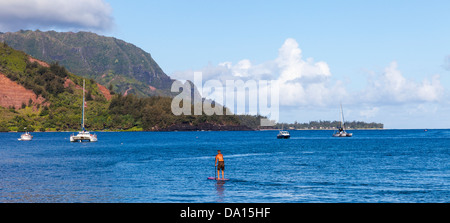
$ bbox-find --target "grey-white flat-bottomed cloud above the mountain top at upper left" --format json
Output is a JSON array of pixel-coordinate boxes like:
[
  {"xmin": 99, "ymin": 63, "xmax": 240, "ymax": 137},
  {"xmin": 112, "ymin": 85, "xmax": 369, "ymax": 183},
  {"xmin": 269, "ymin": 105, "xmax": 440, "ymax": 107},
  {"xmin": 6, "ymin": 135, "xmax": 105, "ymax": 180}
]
[{"xmin": 0, "ymin": 0, "xmax": 114, "ymax": 31}]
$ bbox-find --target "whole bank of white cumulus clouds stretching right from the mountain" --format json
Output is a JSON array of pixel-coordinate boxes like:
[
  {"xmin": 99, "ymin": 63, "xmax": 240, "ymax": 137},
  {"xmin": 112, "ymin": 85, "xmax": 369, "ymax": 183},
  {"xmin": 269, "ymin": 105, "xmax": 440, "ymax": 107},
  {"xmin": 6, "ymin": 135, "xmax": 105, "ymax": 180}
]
[{"xmin": 171, "ymin": 38, "xmax": 444, "ymax": 118}]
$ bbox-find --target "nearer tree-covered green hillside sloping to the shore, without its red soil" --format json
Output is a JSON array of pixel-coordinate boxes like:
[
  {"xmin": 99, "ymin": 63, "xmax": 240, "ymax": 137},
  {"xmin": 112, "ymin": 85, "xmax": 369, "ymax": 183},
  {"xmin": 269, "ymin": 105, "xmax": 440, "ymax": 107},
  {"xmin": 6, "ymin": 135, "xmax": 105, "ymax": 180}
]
[{"xmin": 0, "ymin": 43, "xmax": 251, "ymax": 132}]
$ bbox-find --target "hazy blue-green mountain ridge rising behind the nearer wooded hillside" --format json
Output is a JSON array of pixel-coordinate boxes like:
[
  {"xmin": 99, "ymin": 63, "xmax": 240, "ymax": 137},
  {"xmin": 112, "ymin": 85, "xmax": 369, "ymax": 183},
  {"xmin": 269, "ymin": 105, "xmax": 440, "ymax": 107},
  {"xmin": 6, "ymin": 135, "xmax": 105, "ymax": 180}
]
[{"xmin": 0, "ymin": 30, "xmax": 174, "ymax": 97}]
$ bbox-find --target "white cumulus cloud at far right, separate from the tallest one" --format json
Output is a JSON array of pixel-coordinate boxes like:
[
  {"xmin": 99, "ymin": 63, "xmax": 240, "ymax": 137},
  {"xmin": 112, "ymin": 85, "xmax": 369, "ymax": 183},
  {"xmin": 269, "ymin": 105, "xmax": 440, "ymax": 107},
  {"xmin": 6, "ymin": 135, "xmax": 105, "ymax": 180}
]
[{"xmin": 360, "ymin": 61, "xmax": 444, "ymax": 104}]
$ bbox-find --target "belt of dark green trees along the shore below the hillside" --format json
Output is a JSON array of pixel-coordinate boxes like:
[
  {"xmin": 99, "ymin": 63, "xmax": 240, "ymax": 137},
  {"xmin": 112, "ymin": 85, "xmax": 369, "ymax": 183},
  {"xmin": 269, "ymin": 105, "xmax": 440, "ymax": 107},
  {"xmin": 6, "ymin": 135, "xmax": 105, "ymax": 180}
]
[{"xmin": 0, "ymin": 92, "xmax": 246, "ymax": 131}]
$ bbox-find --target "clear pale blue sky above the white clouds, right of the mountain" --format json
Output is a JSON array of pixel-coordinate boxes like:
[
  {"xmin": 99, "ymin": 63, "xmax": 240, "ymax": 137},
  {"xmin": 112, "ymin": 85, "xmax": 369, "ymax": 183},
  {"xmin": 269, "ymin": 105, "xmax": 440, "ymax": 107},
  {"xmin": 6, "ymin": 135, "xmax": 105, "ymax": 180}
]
[{"xmin": 108, "ymin": 1, "xmax": 450, "ymax": 75}]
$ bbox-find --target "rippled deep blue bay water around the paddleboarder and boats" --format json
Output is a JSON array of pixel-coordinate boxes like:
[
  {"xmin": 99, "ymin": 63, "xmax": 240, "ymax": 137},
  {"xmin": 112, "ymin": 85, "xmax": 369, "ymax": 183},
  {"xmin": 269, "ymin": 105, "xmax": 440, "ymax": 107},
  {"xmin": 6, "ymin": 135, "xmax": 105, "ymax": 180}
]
[{"xmin": 0, "ymin": 130, "xmax": 450, "ymax": 203}]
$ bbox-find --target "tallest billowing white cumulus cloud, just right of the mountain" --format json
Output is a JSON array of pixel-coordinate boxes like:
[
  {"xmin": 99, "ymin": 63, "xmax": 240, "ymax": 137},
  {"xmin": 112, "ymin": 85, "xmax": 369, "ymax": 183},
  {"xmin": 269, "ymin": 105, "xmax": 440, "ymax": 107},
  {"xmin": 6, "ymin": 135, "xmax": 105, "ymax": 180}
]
[{"xmin": 171, "ymin": 38, "xmax": 347, "ymax": 106}]
